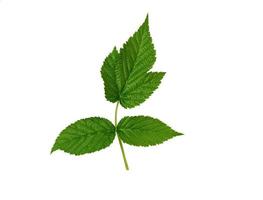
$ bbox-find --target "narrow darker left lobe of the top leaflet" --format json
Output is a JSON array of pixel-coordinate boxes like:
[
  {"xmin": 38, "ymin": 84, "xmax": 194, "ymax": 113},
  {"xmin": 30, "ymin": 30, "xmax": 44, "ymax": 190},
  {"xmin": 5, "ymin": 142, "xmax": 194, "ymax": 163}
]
[{"xmin": 101, "ymin": 47, "xmax": 119, "ymax": 103}]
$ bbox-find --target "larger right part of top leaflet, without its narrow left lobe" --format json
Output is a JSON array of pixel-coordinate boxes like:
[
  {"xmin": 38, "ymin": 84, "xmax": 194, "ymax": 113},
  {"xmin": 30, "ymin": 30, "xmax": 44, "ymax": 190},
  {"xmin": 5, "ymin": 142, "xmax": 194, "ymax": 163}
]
[{"xmin": 115, "ymin": 15, "xmax": 164, "ymax": 108}]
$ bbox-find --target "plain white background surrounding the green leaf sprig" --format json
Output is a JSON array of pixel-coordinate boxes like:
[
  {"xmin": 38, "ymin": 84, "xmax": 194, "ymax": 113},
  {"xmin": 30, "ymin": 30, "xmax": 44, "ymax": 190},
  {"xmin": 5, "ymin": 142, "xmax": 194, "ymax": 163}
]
[{"xmin": 0, "ymin": 0, "xmax": 263, "ymax": 200}]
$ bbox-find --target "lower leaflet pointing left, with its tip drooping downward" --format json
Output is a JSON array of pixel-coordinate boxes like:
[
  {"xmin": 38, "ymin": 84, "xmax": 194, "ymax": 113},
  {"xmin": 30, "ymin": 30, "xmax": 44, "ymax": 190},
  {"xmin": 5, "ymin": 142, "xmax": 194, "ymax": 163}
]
[{"xmin": 51, "ymin": 117, "xmax": 115, "ymax": 155}]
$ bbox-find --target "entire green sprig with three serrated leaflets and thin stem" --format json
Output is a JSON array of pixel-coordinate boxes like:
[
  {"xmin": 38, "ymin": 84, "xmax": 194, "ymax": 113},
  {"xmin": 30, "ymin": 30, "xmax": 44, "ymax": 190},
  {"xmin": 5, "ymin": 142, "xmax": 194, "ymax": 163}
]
[{"xmin": 51, "ymin": 16, "xmax": 182, "ymax": 170}]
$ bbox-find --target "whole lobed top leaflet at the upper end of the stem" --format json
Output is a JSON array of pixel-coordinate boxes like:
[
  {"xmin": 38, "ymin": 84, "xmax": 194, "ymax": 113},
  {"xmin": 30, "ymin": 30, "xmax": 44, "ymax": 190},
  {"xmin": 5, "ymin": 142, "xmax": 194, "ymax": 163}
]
[{"xmin": 101, "ymin": 16, "xmax": 165, "ymax": 108}]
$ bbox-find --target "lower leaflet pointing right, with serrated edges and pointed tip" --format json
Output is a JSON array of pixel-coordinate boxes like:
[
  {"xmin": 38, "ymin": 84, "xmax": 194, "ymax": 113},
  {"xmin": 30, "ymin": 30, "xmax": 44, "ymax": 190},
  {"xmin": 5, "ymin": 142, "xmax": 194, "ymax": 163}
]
[{"xmin": 117, "ymin": 116, "xmax": 183, "ymax": 146}]
